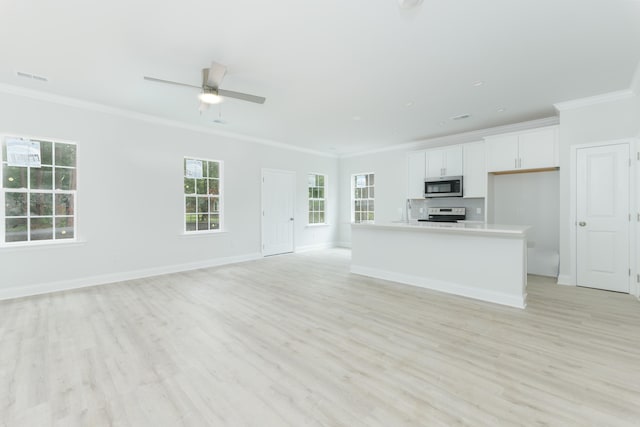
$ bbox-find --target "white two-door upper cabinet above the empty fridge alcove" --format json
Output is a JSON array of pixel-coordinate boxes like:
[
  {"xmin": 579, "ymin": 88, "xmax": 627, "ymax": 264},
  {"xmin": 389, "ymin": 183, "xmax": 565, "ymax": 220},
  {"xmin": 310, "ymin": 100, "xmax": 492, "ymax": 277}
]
[{"xmin": 485, "ymin": 126, "xmax": 559, "ymax": 172}]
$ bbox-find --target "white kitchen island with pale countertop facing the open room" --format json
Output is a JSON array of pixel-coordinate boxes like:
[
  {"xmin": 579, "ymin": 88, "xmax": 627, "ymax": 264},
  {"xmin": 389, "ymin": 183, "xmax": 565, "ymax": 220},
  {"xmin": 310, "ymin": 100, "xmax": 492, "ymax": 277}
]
[{"xmin": 351, "ymin": 222, "xmax": 529, "ymax": 308}]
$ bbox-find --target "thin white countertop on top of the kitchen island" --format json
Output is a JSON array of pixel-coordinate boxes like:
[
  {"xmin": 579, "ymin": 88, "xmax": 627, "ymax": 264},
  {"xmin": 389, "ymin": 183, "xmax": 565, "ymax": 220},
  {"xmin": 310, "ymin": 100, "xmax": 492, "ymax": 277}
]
[{"xmin": 351, "ymin": 221, "xmax": 531, "ymax": 237}]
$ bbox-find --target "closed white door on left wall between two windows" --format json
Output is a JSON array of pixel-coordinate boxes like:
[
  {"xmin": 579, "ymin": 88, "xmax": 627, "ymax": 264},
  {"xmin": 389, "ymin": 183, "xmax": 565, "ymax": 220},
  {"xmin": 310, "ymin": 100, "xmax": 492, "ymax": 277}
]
[{"xmin": 262, "ymin": 169, "xmax": 296, "ymax": 256}]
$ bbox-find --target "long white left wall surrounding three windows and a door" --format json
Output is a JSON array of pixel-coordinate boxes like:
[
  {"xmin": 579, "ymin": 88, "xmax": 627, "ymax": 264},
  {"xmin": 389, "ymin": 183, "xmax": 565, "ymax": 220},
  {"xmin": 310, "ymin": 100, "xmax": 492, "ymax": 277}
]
[{"xmin": 0, "ymin": 94, "xmax": 339, "ymax": 298}]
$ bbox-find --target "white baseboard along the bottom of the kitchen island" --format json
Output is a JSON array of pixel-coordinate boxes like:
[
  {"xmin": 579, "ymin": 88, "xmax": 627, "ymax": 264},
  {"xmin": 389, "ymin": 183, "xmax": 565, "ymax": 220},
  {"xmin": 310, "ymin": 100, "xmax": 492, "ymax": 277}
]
[{"xmin": 351, "ymin": 265, "xmax": 527, "ymax": 308}]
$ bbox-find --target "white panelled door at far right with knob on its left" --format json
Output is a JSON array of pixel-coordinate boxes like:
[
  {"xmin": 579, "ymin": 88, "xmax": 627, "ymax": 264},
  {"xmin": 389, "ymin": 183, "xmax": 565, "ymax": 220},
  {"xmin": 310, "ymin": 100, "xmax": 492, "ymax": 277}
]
[{"xmin": 576, "ymin": 144, "xmax": 630, "ymax": 293}]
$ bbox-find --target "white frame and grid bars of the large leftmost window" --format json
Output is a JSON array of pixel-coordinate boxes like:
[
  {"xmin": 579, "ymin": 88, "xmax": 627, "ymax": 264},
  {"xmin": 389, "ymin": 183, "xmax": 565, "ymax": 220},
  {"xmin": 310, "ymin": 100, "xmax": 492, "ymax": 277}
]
[{"xmin": 0, "ymin": 134, "xmax": 80, "ymax": 248}]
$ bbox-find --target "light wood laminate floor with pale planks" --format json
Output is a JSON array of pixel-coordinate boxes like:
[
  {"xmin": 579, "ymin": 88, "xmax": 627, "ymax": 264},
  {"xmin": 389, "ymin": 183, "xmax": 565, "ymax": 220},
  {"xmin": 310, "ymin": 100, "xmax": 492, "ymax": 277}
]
[{"xmin": 0, "ymin": 249, "xmax": 640, "ymax": 427}]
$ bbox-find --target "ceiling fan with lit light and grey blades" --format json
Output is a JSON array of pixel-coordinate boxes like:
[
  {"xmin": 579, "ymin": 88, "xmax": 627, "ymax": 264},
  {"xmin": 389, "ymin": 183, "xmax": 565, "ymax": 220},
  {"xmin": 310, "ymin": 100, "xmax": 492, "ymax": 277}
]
[{"xmin": 144, "ymin": 62, "xmax": 266, "ymax": 110}]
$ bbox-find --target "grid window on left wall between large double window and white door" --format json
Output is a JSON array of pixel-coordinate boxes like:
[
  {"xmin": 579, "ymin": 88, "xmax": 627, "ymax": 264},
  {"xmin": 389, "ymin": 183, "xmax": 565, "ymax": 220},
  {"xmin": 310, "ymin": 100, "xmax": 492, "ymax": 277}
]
[{"xmin": 184, "ymin": 157, "xmax": 222, "ymax": 232}]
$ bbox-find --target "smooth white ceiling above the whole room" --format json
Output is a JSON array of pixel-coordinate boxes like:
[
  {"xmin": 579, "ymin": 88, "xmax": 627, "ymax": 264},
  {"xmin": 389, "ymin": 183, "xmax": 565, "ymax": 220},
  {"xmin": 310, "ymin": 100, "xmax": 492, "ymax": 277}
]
[{"xmin": 0, "ymin": 0, "xmax": 640, "ymax": 154}]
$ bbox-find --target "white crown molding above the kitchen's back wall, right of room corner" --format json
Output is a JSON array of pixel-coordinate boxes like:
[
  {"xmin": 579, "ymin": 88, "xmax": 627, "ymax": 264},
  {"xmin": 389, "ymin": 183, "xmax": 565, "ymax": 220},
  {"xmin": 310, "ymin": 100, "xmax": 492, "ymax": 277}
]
[{"xmin": 340, "ymin": 116, "xmax": 560, "ymax": 159}]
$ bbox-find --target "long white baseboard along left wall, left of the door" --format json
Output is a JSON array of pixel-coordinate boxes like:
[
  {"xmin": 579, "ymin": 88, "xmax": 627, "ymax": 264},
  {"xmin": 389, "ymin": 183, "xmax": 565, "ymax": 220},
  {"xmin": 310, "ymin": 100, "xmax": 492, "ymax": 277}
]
[{"xmin": 0, "ymin": 253, "xmax": 262, "ymax": 301}]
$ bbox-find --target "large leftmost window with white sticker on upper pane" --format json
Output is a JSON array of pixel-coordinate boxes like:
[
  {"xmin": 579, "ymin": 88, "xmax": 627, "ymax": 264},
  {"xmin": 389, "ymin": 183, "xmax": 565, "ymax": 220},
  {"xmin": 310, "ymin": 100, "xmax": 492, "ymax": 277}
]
[{"xmin": 2, "ymin": 137, "xmax": 76, "ymax": 243}]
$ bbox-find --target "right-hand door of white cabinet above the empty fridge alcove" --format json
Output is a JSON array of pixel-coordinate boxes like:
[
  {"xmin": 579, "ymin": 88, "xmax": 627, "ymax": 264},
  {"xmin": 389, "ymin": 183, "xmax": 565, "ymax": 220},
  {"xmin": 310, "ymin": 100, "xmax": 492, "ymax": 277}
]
[{"xmin": 519, "ymin": 128, "xmax": 559, "ymax": 169}]
